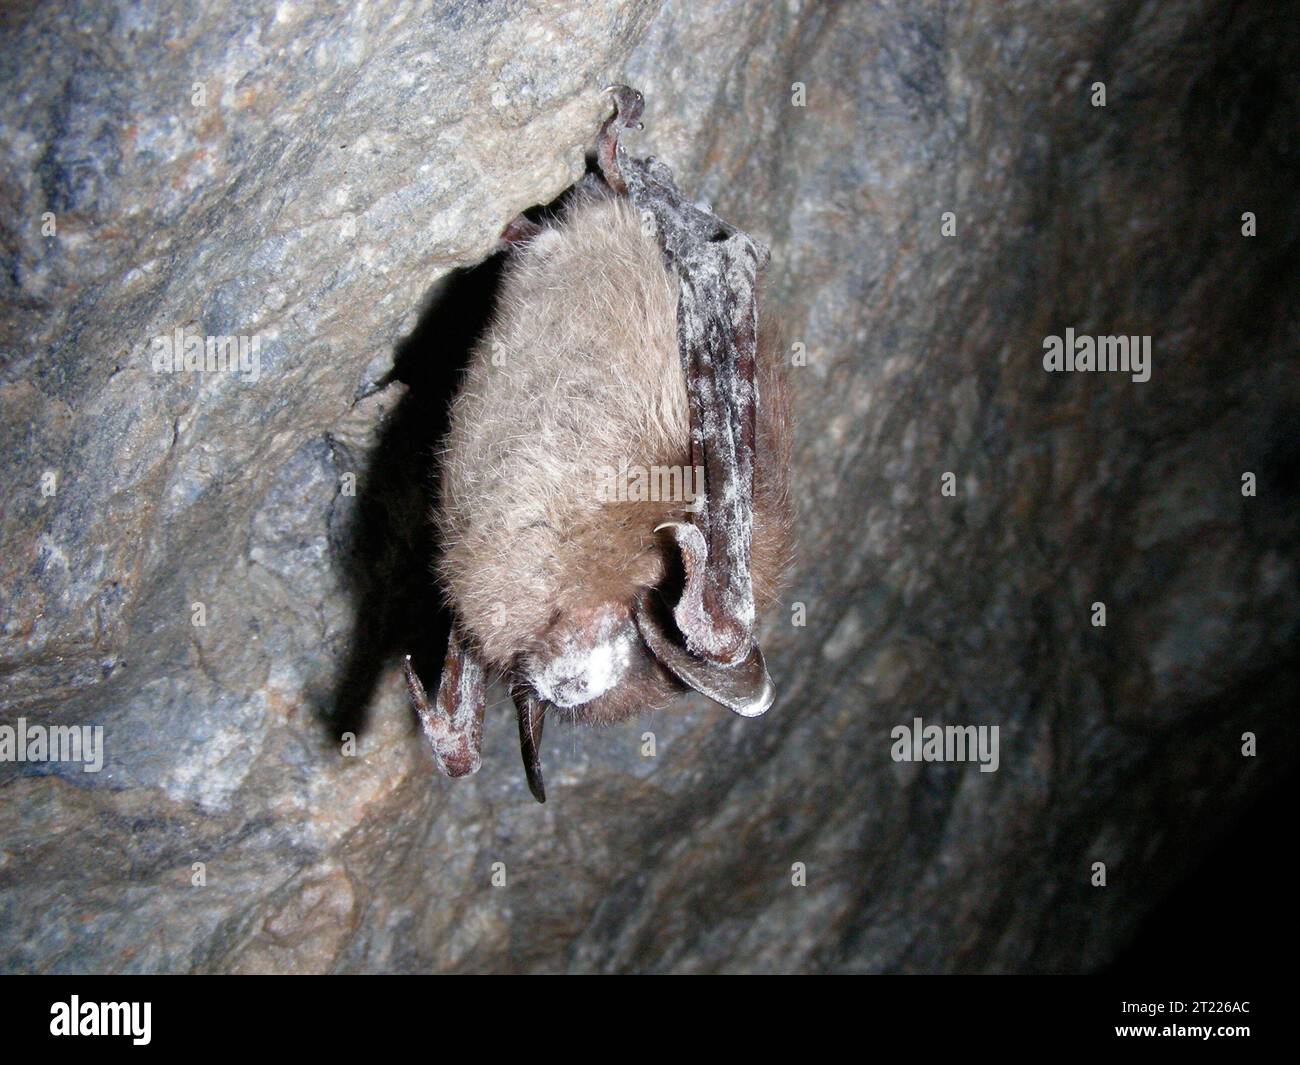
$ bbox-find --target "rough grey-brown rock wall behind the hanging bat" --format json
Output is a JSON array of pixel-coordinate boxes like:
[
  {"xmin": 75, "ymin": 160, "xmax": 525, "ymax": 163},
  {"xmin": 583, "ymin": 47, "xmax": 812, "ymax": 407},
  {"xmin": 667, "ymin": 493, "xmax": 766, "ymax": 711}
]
[{"xmin": 0, "ymin": 0, "xmax": 1300, "ymax": 973}]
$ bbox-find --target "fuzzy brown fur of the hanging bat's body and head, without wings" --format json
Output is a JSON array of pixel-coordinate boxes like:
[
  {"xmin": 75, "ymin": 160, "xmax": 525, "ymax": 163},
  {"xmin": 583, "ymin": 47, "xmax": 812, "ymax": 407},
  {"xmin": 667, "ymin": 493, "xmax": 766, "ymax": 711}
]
[{"xmin": 437, "ymin": 183, "xmax": 792, "ymax": 723}]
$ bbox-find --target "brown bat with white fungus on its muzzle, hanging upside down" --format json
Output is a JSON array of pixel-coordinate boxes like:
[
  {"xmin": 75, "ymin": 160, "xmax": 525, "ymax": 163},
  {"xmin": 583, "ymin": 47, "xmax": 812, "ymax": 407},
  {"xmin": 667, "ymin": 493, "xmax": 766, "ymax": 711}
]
[{"xmin": 406, "ymin": 86, "xmax": 790, "ymax": 802}]
